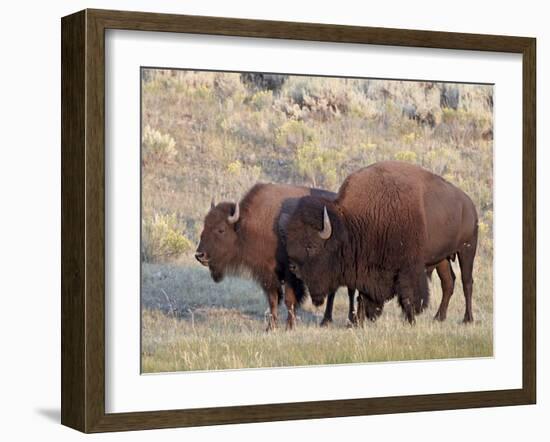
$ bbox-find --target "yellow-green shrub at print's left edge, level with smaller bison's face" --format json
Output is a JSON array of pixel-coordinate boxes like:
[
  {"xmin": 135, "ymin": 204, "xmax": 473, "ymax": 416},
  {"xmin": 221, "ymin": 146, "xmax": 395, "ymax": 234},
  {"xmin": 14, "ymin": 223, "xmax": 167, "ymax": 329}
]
[{"xmin": 142, "ymin": 213, "xmax": 193, "ymax": 262}]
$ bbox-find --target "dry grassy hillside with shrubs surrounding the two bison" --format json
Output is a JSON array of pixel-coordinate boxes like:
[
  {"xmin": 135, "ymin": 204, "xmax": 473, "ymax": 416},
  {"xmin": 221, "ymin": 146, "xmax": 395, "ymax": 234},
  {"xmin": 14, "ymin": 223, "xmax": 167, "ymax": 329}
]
[{"xmin": 142, "ymin": 70, "xmax": 493, "ymax": 371}]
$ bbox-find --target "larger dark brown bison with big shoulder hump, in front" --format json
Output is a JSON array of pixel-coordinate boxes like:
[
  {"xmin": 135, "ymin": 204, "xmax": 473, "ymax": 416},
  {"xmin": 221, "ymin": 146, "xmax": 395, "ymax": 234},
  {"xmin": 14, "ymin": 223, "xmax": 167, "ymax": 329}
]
[{"xmin": 286, "ymin": 161, "xmax": 478, "ymax": 323}]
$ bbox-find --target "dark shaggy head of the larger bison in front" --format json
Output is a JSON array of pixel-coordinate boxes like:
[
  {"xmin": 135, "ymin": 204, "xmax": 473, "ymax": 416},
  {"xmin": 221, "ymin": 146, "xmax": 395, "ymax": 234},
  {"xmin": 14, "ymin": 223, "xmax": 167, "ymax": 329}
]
[{"xmin": 285, "ymin": 196, "xmax": 345, "ymax": 305}]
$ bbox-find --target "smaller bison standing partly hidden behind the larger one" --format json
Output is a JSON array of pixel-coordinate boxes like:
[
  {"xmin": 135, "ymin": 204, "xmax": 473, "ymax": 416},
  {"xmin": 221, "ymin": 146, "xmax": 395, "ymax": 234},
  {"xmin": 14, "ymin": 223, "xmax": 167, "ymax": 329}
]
[{"xmin": 195, "ymin": 183, "xmax": 355, "ymax": 330}]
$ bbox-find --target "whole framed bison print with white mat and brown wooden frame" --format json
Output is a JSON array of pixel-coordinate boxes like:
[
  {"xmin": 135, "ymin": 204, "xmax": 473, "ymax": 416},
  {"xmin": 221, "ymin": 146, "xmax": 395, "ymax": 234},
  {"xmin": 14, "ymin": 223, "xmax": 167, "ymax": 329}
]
[{"xmin": 61, "ymin": 10, "xmax": 536, "ymax": 432}]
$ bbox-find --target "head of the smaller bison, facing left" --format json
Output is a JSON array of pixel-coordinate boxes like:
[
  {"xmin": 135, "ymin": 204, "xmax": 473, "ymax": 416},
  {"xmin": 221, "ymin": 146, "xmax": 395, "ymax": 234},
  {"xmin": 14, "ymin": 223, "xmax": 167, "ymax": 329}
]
[{"xmin": 195, "ymin": 202, "xmax": 240, "ymax": 282}]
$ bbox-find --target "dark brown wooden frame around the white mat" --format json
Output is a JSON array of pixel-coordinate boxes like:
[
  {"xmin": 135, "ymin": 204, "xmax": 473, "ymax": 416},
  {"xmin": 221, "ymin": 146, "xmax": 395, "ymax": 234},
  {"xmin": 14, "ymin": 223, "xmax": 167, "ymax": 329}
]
[{"xmin": 61, "ymin": 10, "xmax": 536, "ymax": 432}]
